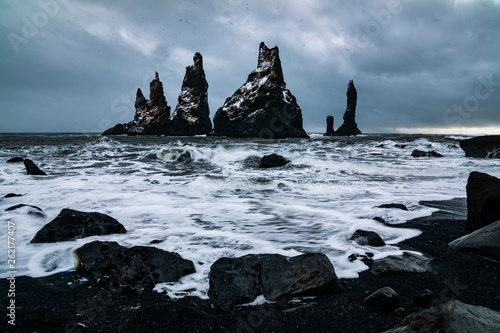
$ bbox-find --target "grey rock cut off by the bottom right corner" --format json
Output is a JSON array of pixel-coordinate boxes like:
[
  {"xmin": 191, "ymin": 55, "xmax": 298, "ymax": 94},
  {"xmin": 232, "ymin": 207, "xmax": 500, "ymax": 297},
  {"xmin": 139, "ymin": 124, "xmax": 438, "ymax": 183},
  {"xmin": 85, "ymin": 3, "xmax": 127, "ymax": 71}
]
[{"xmin": 385, "ymin": 300, "xmax": 500, "ymax": 333}]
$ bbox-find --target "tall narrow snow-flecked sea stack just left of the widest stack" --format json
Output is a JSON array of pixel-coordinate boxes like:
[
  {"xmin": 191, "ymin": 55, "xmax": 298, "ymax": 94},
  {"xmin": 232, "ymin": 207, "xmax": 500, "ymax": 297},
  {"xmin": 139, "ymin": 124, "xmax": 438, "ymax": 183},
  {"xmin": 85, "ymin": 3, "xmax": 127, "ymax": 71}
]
[{"xmin": 169, "ymin": 52, "xmax": 212, "ymax": 135}]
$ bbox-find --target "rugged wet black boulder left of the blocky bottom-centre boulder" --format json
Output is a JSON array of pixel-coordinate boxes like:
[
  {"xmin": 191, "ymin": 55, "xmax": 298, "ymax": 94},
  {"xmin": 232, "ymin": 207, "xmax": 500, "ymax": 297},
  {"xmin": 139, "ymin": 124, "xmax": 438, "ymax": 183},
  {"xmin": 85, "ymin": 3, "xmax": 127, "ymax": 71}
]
[{"xmin": 73, "ymin": 241, "xmax": 196, "ymax": 289}]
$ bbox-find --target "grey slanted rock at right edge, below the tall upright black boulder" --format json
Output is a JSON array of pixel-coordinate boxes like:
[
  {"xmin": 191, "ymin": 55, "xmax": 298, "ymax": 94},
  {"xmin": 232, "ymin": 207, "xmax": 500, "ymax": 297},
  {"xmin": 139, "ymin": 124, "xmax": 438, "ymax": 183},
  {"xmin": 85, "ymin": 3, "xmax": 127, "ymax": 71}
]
[{"xmin": 448, "ymin": 221, "xmax": 500, "ymax": 260}]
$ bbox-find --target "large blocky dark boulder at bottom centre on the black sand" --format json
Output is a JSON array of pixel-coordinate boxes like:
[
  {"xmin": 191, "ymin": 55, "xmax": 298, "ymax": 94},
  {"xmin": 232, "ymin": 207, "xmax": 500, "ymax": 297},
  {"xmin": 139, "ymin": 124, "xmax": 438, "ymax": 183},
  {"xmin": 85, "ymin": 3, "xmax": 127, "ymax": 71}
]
[{"xmin": 208, "ymin": 253, "xmax": 342, "ymax": 310}]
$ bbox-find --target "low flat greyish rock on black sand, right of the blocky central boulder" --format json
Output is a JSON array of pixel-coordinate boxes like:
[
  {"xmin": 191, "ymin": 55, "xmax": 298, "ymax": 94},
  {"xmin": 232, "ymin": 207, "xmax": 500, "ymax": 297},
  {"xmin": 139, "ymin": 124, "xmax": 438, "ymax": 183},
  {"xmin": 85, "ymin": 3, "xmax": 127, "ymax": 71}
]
[{"xmin": 371, "ymin": 252, "xmax": 430, "ymax": 275}]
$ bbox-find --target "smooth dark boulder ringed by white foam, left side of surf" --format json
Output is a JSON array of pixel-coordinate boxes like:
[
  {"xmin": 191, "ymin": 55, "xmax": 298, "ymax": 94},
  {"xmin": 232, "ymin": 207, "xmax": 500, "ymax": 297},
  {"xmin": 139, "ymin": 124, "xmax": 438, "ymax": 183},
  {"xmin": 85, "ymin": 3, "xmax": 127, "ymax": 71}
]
[{"xmin": 31, "ymin": 209, "xmax": 127, "ymax": 243}]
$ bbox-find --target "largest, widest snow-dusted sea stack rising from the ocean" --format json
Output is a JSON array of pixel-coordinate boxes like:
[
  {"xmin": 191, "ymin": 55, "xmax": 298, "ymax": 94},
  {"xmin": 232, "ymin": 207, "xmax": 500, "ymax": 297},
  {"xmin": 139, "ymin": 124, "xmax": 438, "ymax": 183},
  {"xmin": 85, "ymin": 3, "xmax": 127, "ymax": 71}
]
[{"xmin": 212, "ymin": 42, "xmax": 308, "ymax": 138}]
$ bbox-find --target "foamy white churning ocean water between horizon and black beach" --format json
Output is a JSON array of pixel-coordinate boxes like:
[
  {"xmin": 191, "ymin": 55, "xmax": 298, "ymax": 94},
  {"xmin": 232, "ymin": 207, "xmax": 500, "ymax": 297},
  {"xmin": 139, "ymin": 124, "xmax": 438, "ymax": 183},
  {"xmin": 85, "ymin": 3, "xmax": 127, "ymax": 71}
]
[{"xmin": 0, "ymin": 134, "xmax": 500, "ymax": 298}]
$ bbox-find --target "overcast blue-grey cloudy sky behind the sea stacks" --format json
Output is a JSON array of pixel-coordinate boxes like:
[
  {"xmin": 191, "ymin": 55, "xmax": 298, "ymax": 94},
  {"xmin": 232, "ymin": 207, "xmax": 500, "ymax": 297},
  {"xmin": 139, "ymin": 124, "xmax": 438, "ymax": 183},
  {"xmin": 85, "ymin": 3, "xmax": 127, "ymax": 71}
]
[{"xmin": 0, "ymin": 0, "xmax": 500, "ymax": 134}]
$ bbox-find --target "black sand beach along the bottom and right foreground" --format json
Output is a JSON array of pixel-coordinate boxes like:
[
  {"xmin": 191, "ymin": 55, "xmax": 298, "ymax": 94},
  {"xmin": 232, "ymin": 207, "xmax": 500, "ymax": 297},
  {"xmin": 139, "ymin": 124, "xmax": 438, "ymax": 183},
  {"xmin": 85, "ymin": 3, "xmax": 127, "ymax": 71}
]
[{"xmin": 0, "ymin": 198, "xmax": 500, "ymax": 332}]
